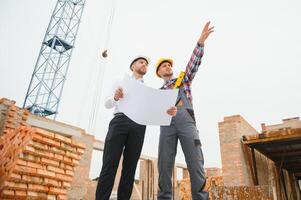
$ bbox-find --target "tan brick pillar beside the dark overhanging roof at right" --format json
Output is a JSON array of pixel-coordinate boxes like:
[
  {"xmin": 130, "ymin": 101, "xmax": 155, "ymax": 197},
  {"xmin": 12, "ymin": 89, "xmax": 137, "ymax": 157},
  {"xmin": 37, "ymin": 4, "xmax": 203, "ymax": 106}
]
[{"xmin": 218, "ymin": 115, "xmax": 258, "ymax": 186}]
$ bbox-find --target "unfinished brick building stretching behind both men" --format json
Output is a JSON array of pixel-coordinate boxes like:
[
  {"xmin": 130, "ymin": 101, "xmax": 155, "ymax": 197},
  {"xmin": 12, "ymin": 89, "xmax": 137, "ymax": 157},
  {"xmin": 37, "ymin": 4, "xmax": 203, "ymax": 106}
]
[{"xmin": 0, "ymin": 98, "xmax": 301, "ymax": 200}]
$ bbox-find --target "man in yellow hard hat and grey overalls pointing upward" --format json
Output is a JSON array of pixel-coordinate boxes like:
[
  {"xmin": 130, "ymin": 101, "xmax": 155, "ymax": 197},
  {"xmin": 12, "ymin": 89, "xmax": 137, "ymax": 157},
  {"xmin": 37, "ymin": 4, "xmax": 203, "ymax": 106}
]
[{"xmin": 156, "ymin": 22, "xmax": 214, "ymax": 200}]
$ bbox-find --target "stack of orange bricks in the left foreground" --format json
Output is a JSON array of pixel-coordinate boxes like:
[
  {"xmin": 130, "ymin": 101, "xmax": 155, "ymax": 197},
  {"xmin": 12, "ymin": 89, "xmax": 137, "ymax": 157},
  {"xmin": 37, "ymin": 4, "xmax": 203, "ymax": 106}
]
[{"xmin": 0, "ymin": 126, "xmax": 84, "ymax": 200}]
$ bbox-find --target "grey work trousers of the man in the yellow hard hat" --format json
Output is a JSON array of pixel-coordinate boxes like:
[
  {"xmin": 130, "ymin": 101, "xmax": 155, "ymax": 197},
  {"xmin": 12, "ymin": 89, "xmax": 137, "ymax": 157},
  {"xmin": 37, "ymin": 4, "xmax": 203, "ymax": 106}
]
[{"xmin": 158, "ymin": 108, "xmax": 209, "ymax": 200}]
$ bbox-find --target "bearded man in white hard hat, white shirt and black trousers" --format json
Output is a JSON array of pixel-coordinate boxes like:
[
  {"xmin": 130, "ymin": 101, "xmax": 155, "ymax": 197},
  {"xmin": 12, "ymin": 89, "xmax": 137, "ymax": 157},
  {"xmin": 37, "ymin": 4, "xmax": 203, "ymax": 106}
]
[{"xmin": 96, "ymin": 56, "xmax": 177, "ymax": 200}]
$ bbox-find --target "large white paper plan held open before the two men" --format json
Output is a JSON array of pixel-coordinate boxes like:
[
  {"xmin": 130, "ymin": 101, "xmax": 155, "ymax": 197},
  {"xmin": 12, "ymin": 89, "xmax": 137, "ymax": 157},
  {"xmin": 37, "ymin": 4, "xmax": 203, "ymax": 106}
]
[{"xmin": 119, "ymin": 75, "xmax": 178, "ymax": 126}]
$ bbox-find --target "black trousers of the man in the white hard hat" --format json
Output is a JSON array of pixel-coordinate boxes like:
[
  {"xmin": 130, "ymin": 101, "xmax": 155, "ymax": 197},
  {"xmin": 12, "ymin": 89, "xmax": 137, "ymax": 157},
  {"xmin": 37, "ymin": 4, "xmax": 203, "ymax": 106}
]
[{"xmin": 96, "ymin": 113, "xmax": 146, "ymax": 200}]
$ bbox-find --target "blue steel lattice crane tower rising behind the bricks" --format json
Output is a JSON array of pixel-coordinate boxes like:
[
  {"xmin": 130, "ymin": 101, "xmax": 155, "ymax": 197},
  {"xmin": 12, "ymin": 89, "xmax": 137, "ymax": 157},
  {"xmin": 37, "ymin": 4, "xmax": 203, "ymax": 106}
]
[{"xmin": 23, "ymin": 0, "xmax": 85, "ymax": 118}]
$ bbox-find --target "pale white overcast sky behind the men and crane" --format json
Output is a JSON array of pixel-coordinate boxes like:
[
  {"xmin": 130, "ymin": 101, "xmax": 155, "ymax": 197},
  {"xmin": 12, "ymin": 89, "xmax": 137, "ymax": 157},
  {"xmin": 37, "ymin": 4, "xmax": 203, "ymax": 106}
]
[{"xmin": 0, "ymin": 0, "xmax": 301, "ymax": 177}]
